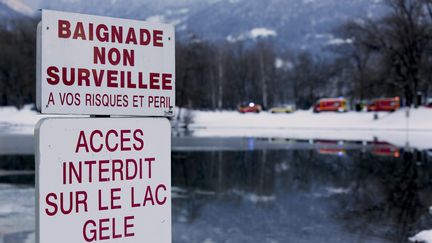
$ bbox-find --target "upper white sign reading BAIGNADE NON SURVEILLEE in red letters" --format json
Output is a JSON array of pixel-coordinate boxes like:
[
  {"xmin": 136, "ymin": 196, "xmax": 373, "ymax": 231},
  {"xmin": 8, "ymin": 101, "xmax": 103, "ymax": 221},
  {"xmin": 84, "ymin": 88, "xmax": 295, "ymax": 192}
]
[{"xmin": 37, "ymin": 10, "xmax": 175, "ymax": 116}]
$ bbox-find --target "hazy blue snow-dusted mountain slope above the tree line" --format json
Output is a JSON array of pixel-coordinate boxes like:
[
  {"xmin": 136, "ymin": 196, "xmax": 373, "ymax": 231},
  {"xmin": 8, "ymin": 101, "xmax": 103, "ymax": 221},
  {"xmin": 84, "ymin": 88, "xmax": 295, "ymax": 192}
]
[{"xmin": 6, "ymin": 0, "xmax": 382, "ymax": 51}]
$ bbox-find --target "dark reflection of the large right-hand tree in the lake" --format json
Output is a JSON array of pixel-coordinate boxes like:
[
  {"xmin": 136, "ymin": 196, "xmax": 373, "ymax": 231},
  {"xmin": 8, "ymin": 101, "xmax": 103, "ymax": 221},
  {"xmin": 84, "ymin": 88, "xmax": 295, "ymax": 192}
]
[{"xmin": 338, "ymin": 152, "xmax": 432, "ymax": 242}]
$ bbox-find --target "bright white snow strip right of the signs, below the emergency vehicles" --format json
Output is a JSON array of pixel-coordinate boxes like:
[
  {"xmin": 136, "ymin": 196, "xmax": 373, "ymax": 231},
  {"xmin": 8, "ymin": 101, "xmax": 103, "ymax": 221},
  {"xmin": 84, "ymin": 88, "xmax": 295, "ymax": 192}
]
[{"xmin": 191, "ymin": 108, "xmax": 432, "ymax": 131}]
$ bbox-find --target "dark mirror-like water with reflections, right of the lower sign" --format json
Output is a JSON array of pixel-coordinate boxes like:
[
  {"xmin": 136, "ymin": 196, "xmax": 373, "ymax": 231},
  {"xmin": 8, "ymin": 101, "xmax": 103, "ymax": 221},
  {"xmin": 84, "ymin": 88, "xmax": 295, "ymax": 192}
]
[{"xmin": 172, "ymin": 141, "xmax": 432, "ymax": 242}]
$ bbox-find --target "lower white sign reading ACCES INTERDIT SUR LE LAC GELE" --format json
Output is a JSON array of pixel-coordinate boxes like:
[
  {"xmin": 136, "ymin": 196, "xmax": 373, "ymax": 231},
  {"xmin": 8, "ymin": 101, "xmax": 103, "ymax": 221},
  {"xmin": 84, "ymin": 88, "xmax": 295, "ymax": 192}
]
[{"xmin": 36, "ymin": 118, "xmax": 171, "ymax": 243}]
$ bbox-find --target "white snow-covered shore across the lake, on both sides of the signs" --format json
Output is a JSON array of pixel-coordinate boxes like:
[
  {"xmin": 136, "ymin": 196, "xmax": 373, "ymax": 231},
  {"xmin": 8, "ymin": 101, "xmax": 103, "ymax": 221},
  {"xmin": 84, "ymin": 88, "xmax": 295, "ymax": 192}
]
[{"xmin": 0, "ymin": 106, "xmax": 432, "ymax": 149}]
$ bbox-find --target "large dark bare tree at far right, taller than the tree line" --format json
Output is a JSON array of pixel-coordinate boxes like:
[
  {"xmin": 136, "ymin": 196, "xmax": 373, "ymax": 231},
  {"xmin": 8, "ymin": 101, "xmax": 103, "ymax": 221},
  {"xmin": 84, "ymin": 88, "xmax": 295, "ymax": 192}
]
[{"xmin": 334, "ymin": 0, "xmax": 431, "ymax": 105}]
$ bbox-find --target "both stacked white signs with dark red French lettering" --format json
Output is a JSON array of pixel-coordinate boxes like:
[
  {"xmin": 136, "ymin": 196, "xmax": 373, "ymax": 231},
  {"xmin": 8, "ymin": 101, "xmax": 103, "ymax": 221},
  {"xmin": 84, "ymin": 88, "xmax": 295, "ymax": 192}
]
[{"xmin": 35, "ymin": 10, "xmax": 175, "ymax": 243}]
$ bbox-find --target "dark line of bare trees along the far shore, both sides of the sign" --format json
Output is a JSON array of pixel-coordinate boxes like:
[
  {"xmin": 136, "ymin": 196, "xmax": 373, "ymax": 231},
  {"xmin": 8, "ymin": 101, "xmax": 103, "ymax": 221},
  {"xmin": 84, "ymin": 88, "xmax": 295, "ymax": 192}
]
[{"xmin": 0, "ymin": 0, "xmax": 432, "ymax": 109}]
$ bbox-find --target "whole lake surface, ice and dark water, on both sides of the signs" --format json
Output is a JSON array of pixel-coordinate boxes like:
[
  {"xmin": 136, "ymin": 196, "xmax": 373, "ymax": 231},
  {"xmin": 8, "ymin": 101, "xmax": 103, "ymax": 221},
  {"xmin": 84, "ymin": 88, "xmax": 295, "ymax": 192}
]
[{"xmin": 0, "ymin": 132, "xmax": 432, "ymax": 243}]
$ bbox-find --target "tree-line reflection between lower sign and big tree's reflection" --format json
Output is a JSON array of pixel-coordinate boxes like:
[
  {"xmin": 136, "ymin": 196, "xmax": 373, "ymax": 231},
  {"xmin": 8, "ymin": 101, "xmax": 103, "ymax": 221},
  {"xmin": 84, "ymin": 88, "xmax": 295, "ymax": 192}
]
[{"xmin": 172, "ymin": 150, "xmax": 346, "ymax": 224}]
